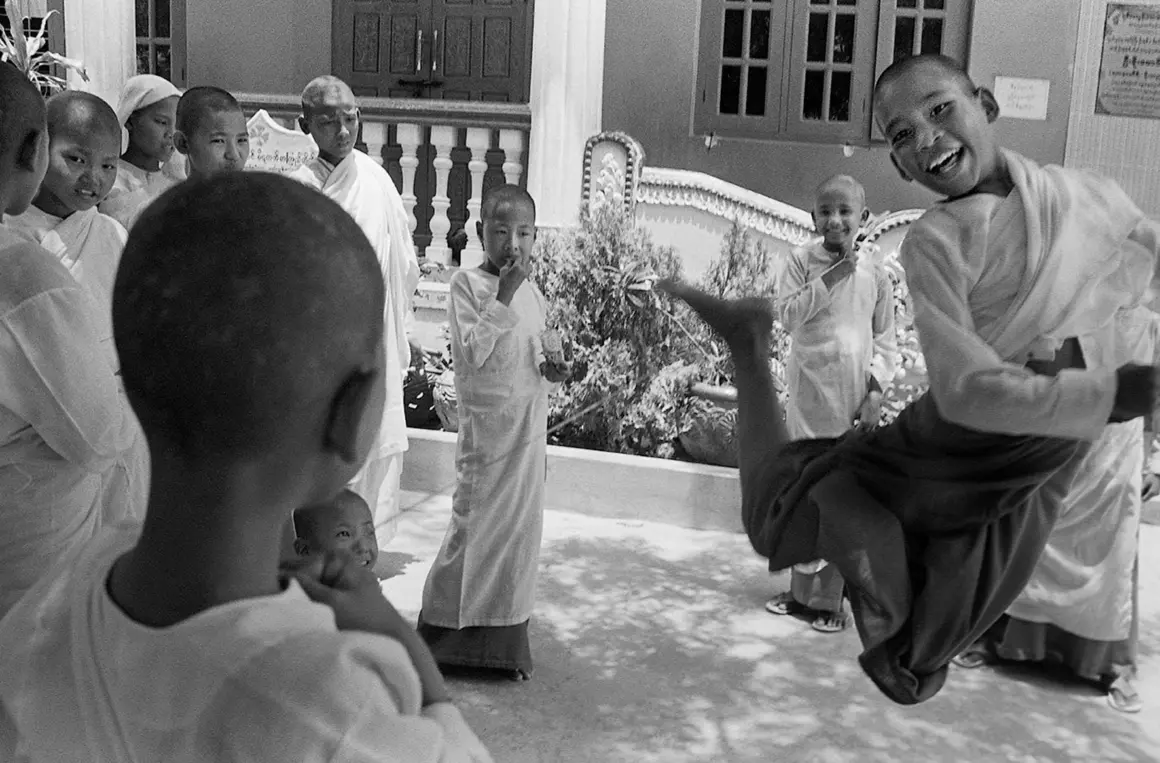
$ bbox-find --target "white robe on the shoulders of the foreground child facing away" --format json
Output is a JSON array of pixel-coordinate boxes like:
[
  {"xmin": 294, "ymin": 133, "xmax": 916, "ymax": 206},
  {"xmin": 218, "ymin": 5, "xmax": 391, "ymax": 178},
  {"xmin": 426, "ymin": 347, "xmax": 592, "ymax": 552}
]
[{"xmin": 0, "ymin": 525, "xmax": 490, "ymax": 763}]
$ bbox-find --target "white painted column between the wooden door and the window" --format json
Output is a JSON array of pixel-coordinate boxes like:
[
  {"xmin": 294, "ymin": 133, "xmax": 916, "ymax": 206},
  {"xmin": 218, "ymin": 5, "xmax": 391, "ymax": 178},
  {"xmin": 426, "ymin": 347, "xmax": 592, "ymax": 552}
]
[{"xmin": 527, "ymin": 0, "xmax": 606, "ymax": 227}]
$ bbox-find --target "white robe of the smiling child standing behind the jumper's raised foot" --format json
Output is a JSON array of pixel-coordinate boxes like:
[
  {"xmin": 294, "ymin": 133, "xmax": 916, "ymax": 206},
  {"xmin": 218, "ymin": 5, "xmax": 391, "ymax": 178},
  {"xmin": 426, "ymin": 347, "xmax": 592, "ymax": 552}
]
[{"xmin": 776, "ymin": 242, "xmax": 898, "ymax": 439}]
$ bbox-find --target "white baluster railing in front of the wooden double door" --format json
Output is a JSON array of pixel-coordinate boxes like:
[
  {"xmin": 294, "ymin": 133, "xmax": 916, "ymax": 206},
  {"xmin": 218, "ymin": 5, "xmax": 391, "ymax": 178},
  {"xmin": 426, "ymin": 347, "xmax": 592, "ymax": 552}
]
[{"xmin": 237, "ymin": 93, "xmax": 531, "ymax": 266}]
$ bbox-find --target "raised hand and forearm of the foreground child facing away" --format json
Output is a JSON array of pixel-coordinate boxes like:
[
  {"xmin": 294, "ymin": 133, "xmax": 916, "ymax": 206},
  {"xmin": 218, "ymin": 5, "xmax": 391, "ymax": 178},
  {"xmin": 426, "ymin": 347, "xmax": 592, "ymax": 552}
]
[{"xmin": 283, "ymin": 551, "xmax": 451, "ymax": 706}]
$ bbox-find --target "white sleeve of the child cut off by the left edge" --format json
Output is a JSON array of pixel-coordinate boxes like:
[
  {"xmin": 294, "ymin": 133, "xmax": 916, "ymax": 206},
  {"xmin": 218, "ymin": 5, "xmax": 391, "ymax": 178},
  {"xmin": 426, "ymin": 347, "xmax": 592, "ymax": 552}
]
[{"xmin": 0, "ymin": 284, "xmax": 135, "ymax": 473}]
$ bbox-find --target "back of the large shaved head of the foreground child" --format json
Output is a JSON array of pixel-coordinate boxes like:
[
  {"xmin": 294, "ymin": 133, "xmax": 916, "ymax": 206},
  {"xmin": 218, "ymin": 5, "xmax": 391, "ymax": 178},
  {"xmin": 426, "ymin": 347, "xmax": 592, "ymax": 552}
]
[{"xmin": 113, "ymin": 173, "xmax": 384, "ymax": 459}]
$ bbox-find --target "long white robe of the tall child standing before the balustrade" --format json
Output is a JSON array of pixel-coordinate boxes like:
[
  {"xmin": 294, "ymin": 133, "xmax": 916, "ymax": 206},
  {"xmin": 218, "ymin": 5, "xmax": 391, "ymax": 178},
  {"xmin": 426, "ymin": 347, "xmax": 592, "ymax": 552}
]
[{"xmin": 290, "ymin": 150, "xmax": 419, "ymax": 545}]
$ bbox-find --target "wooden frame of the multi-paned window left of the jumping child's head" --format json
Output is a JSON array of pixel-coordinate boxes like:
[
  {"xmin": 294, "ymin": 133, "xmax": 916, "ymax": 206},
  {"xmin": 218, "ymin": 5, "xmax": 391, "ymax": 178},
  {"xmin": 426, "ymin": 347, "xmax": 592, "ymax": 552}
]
[{"xmin": 690, "ymin": 0, "xmax": 973, "ymax": 146}]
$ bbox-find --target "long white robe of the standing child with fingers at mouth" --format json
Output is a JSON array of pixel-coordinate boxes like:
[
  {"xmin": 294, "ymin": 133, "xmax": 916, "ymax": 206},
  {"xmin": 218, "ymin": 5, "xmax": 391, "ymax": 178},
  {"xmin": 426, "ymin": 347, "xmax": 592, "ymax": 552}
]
[{"xmin": 422, "ymin": 269, "xmax": 553, "ymax": 630}]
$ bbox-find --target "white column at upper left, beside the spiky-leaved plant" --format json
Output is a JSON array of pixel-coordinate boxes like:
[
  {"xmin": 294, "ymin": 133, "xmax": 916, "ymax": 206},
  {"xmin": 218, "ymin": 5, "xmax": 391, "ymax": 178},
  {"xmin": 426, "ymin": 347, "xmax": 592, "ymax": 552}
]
[{"xmin": 65, "ymin": 0, "xmax": 137, "ymax": 108}]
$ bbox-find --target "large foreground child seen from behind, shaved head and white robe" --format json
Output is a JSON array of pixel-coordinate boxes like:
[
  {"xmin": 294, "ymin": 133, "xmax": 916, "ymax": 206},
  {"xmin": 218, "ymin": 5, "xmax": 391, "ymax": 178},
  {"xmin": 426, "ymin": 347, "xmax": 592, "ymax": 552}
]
[{"xmin": 0, "ymin": 173, "xmax": 490, "ymax": 763}]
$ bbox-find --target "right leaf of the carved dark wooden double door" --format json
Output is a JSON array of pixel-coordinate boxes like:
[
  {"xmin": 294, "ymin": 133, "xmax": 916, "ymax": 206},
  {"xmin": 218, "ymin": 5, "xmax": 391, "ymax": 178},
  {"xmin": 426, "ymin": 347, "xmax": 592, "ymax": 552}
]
[{"xmin": 432, "ymin": 0, "xmax": 531, "ymax": 103}]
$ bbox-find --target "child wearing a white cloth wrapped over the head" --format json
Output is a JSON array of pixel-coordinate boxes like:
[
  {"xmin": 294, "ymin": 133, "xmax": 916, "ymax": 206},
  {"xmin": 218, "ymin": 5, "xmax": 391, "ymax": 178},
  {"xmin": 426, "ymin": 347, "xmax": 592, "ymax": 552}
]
[{"xmin": 101, "ymin": 74, "xmax": 184, "ymax": 230}]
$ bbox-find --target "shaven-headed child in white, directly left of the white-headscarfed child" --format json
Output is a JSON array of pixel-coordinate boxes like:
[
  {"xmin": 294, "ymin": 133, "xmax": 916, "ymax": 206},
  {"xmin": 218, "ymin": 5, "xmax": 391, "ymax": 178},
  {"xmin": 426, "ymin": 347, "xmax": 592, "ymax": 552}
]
[{"xmin": 7, "ymin": 90, "xmax": 126, "ymax": 352}]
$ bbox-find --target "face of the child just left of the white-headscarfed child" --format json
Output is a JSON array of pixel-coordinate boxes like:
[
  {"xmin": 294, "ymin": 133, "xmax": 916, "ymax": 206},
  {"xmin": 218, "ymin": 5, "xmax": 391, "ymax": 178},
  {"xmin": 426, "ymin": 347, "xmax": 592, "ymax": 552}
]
[{"xmin": 36, "ymin": 123, "xmax": 121, "ymax": 217}]
